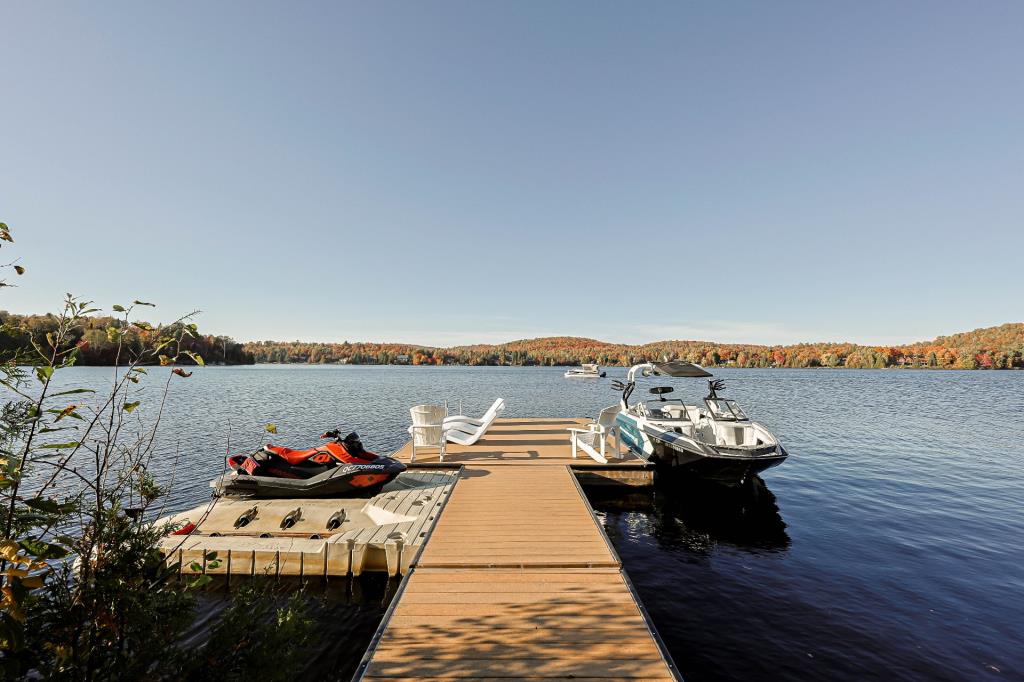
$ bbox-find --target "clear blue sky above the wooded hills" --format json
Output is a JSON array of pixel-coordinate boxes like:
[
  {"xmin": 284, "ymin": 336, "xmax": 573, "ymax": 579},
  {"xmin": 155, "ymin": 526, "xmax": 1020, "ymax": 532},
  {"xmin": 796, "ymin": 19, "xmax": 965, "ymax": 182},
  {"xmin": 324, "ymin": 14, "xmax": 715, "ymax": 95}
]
[{"xmin": 0, "ymin": 1, "xmax": 1024, "ymax": 344}]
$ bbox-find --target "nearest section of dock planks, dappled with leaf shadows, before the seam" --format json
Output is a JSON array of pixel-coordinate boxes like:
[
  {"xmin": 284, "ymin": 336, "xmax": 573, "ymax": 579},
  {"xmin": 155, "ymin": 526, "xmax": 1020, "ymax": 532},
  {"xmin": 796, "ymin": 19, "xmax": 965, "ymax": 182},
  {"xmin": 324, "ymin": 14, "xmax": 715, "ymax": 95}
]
[{"xmin": 364, "ymin": 568, "xmax": 674, "ymax": 680}]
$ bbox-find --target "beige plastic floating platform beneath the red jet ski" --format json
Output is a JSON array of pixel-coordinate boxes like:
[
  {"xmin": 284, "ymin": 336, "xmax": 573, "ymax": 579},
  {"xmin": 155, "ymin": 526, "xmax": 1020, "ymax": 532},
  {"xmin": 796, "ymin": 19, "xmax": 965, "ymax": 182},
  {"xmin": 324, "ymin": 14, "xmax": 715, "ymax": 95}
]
[{"xmin": 159, "ymin": 470, "xmax": 458, "ymax": 578}]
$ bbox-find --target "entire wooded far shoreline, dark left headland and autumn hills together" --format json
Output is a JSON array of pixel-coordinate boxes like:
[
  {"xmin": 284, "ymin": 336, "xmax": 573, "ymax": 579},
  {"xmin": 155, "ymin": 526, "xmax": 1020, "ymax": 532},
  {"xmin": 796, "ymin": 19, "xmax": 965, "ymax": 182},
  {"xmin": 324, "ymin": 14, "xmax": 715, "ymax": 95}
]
[{"xmin": 0, "ymin": 311, "xmax": 1024, "ymax": 370}]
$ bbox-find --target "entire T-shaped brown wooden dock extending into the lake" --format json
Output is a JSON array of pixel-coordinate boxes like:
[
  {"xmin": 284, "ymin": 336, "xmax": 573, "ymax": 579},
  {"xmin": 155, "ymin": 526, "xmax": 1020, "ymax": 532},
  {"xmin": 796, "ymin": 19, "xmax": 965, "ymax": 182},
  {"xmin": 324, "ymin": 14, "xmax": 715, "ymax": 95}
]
[{"xmin": 356, "ymin": 419, "xmax": 678, "ymax": 680}]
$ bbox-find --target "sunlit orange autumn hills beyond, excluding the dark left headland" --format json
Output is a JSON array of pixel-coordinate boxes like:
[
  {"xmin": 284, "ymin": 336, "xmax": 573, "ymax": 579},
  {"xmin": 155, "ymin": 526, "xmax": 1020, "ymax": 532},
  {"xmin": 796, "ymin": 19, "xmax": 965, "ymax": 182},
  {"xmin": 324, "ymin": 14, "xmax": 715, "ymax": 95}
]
[{"xmin": 244, "ymin": 323, "xmax": 1024, "ymax": 370}]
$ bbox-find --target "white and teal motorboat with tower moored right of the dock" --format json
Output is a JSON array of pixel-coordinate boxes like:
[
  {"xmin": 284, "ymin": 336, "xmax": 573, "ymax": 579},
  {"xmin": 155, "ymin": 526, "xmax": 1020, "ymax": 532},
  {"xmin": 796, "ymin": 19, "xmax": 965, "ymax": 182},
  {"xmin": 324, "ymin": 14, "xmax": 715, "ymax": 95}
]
[{"xmin": 612, "ymin": 360, "xmax": 788, "ymax": 485}]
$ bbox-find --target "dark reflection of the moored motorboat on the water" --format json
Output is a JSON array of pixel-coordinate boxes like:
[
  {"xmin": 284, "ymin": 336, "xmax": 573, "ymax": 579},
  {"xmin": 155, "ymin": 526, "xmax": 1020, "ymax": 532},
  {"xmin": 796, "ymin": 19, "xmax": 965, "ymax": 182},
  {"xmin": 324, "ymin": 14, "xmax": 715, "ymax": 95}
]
[{"xmin": 588, "ymin": 476, "xmax": 790, "ymax": 552}]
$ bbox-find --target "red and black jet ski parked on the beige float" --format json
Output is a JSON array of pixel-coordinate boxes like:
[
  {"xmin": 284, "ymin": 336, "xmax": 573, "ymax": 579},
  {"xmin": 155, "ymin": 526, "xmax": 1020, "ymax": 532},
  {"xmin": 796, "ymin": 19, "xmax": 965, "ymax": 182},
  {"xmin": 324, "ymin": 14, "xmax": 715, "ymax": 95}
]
[{"xmin": 211, "ymin": 430, "xmax": 406, "ymax": 498}]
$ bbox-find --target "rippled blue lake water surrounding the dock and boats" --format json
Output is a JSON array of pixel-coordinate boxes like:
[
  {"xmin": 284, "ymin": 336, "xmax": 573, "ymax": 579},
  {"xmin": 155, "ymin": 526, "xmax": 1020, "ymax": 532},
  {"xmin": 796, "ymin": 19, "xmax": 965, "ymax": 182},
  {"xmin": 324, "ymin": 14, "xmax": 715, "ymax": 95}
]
[{"xmin": 36, "ymin": 366, "xmax": 1024, "ymax": 681}]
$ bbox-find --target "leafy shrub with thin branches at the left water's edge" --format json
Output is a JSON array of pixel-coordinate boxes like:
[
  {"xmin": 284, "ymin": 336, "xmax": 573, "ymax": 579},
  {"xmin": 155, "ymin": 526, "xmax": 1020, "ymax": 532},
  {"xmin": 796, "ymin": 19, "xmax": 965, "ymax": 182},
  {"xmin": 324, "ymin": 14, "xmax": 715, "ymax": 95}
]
[{"xmin": 0, "ymin": 223, "xmax": 309, "ymax": 680}]
